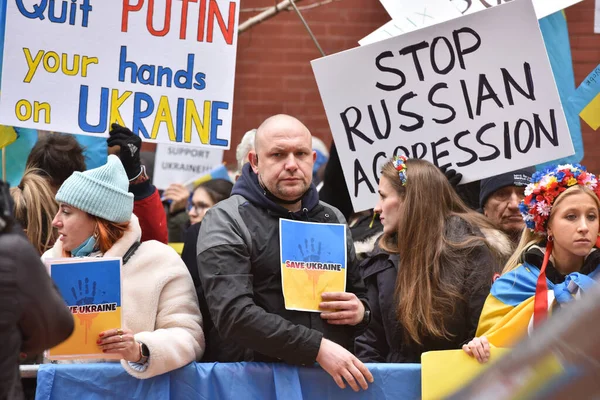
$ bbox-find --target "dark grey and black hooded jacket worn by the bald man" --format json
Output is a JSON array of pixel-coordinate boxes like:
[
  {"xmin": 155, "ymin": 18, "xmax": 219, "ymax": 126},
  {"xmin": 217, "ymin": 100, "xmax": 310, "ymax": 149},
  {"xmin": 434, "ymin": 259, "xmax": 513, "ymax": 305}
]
[{"xmin": 197, "ymin": 164, "xmax": 368, "ymax": 365}]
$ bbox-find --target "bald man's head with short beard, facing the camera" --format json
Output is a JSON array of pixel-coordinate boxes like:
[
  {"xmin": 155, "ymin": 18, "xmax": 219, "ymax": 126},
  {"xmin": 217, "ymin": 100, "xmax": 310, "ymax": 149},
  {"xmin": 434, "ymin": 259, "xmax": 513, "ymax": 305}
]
[{"xmin": 249, "ymin": 114, "xmax": 316, "ymax": 209}]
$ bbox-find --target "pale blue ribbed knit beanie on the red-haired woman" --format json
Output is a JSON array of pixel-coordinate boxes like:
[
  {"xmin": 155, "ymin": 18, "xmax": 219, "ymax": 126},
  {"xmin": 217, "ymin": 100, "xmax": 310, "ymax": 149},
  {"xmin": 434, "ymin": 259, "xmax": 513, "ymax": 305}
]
[{"xmin": 56, "ymin": 155, "xmax": 133, "ymax": 223}]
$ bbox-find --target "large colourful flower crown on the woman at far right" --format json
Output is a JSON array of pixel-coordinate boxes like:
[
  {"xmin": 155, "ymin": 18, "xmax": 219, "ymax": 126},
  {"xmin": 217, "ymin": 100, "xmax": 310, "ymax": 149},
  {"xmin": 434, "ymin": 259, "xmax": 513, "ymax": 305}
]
[{"xmin": 519, "ymin": 164, "xmax": 600, "ymax": 235}]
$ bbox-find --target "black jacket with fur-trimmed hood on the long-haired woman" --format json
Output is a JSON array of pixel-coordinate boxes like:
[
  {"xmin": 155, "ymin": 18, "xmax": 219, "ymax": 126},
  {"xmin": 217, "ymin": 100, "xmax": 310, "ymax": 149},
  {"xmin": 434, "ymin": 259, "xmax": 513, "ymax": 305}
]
[{"xmin": 355, "ymin": 217, "xmax": 510, "ymax": 363}]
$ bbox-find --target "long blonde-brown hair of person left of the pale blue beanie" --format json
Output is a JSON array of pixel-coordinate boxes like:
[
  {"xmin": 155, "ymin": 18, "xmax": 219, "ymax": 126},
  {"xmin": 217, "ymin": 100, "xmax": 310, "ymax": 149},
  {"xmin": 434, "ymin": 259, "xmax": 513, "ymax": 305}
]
[{"xmin": 10, "ymin": 168, "xmax": 58, "ymax": 256}]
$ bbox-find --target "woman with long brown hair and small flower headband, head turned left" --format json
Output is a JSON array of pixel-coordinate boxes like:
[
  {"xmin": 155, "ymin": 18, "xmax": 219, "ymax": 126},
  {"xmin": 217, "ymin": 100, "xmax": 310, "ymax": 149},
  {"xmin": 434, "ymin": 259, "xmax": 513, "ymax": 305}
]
[{"xmin": 355, "ymin": 157, "xmax": 510, "ymax": 363}]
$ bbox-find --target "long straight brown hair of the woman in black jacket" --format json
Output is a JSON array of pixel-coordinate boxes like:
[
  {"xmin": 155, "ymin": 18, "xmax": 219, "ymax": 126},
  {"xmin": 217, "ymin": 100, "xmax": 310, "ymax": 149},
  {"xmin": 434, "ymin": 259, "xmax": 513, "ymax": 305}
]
[{"xmin": 380, "ymin": 159, "xmax": 502, "ymax": 344}]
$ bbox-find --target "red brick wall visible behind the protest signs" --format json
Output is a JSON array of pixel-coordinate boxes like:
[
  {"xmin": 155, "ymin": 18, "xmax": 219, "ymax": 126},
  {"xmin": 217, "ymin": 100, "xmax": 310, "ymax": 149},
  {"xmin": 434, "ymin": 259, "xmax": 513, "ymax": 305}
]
[{"xmin": 178, "ymin": 0, "xmax": 600, "ymax": 172}]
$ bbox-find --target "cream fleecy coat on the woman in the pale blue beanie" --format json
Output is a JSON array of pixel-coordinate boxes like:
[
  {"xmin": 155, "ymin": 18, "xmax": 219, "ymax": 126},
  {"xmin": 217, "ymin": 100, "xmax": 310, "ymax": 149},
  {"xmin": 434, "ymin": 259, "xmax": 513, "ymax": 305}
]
[{"xmin": 42, "ymin": 215, "xmax": 205, "ymax": 379}]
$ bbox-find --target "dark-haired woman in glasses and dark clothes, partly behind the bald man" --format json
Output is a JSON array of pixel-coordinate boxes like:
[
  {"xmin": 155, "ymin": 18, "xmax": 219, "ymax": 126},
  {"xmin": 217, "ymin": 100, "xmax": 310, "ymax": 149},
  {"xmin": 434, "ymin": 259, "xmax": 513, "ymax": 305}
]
[{"xmin": 181, "ymin": 179, "xmax": 233, "ymax": 362}]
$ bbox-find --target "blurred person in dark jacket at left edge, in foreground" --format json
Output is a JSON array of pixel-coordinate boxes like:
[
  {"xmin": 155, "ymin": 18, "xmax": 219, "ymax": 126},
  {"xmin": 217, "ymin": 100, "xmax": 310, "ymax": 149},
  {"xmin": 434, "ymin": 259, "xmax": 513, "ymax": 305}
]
[{"xmin": 0, "ymin": 181, "xmax": 74, "ymax": 399}]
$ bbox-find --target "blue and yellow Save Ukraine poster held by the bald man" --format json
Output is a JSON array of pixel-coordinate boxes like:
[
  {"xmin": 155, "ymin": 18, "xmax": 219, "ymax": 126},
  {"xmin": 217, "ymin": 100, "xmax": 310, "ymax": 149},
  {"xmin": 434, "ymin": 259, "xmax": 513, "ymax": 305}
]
[{"xmin": 279, "ymin": 218, "xmax": 346, "ymax": 312}]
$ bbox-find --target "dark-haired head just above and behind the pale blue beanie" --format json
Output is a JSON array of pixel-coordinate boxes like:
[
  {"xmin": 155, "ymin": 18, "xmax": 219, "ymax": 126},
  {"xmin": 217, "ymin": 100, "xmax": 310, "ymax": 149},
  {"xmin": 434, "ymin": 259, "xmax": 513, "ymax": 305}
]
[{"xmin": 25, "ymin": 133, "xmax": 86, "ymax": 194}]
